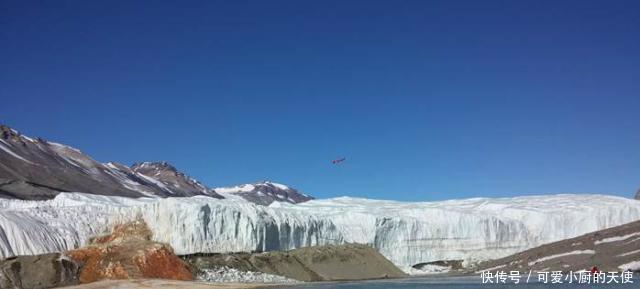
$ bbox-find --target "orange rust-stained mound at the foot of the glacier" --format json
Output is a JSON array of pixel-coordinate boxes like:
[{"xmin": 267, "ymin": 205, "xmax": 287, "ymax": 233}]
[{"xmin": 66, "ymin": 221, "xmax": 193, "ymax": 283}]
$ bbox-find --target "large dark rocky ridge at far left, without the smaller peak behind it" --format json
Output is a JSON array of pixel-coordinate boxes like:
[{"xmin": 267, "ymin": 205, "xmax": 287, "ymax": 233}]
[{"xmin": 0, "ymin": 126, "xmax": 142, "ymax": 199}]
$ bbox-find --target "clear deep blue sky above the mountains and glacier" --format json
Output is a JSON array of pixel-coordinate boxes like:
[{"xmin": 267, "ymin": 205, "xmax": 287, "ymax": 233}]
[{"xmin": 0, "ymin": 0, "xmax": 640, "ymax": 200}]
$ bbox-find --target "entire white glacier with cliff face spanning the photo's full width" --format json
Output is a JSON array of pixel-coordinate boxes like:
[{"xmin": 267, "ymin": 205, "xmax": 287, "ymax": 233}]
[{"xmin": 0, "ymin": 193, "xmax": 640, "ymax": 268}]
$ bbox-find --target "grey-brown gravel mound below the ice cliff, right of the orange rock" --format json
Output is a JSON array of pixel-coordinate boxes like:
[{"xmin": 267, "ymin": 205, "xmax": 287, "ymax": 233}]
[{"xmin": 183, "ymin": 244, "xmax": 406, "ymax": 281}]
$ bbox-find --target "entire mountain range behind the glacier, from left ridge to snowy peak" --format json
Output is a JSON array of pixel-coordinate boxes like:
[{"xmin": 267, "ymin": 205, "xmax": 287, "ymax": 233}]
[{"xmin": 0, "ymin": 125, "xmax": 313, "ymax": 205}]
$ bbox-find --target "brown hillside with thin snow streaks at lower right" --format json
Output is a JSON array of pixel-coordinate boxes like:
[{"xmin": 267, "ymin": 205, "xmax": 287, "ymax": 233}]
[{"xmin": 474, "ymin": 221, "xmax": 640, "ymax": 272}]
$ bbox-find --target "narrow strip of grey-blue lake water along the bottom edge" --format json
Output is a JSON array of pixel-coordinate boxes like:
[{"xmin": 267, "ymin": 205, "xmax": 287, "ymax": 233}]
[{"xmin": 287, "ymin": 277, "xmax": 640, "ymax": 289}]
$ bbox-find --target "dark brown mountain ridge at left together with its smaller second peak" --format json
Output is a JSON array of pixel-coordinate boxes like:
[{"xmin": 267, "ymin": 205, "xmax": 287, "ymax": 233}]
[{"xmin": 0, "ymin": 126, "xmax": 217, "ymax": 199}]
